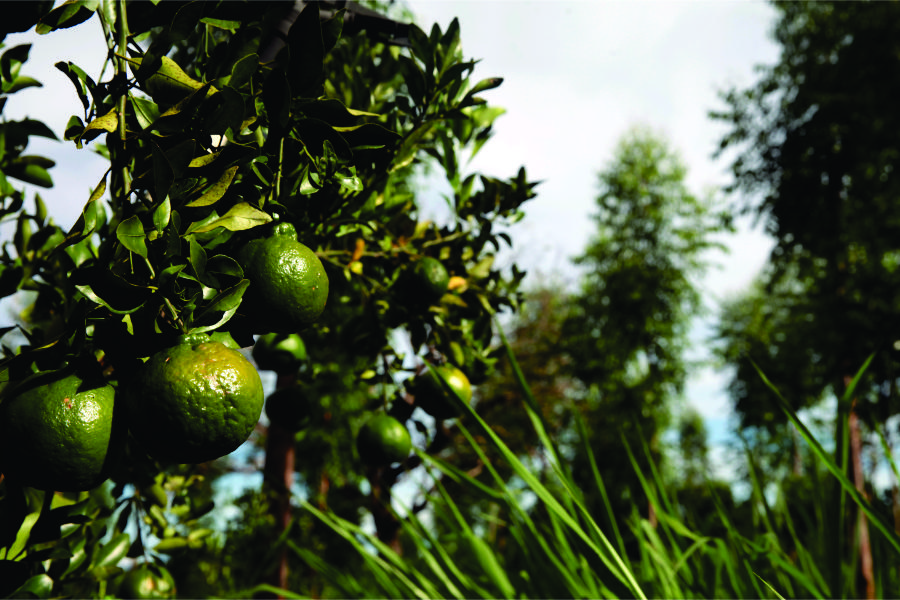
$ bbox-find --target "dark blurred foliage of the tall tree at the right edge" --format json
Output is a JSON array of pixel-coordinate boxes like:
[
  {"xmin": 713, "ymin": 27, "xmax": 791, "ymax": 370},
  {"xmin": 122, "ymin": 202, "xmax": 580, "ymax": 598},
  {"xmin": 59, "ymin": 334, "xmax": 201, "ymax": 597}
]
[{"xmin": 713, "ymin": 2, "xmax": 900, "ymax": 418}]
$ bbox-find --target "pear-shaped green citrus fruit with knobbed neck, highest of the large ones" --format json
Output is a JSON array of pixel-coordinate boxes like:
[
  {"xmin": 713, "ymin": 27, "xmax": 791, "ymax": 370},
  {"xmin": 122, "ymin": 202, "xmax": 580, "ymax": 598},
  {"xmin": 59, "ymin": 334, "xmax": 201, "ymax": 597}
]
[{"xmin": 238, "ymin": 223, "xmax": 328, "ymax": 333}]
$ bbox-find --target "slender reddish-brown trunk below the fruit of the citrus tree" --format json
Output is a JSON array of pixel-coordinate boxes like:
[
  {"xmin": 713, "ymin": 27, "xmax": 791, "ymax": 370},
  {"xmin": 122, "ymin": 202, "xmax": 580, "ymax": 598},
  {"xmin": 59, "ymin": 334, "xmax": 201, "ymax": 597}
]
[{"xmin": 263, "ymin": 375, "xmax": 294, "ymax": 598}]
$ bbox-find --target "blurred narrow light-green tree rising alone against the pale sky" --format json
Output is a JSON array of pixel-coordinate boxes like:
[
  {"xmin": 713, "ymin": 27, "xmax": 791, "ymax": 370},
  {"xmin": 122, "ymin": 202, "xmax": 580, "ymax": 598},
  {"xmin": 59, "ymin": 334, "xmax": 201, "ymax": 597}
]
[{"xmin": 563, "ymin": 129, "xmax": 724, "ymax": 514}]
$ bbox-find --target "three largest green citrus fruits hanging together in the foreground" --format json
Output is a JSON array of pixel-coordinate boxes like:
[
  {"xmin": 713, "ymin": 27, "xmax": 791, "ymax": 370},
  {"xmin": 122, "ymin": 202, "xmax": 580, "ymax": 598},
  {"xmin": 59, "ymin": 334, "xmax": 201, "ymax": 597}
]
[{"xmin": 0, "ymin": 223, "xmax": 328, "ymax": 491}]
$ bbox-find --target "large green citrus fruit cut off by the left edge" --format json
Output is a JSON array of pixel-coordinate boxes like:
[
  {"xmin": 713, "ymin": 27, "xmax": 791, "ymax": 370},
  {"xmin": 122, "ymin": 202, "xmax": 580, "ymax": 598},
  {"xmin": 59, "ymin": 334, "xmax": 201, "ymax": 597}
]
[{"xmin": 0, "ymin": 368, "xmax": 121, "ymax": 491}]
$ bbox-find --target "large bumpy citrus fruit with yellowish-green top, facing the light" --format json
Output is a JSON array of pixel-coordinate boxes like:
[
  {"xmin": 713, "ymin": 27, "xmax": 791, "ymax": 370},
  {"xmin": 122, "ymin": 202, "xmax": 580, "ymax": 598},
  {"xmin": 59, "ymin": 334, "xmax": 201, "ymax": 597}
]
[{"xmin": 124, "ymin": 333, "xmax": 264, "ymax": 463}]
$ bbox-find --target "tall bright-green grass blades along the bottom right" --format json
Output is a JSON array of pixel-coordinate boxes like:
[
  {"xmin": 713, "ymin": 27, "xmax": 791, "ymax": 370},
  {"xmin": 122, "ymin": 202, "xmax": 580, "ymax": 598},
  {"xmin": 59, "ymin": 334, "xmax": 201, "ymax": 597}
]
[{"xmin": 260, "ymin": 338, "xmax": 900, "ymax": 599}]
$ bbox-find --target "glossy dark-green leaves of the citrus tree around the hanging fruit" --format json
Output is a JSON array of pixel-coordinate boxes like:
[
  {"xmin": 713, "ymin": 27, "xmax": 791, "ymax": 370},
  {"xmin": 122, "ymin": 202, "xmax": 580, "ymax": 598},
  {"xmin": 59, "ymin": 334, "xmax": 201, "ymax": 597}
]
[{"xmin": 0, "ymin": 0, "xmax": 534, "ymax": 597}]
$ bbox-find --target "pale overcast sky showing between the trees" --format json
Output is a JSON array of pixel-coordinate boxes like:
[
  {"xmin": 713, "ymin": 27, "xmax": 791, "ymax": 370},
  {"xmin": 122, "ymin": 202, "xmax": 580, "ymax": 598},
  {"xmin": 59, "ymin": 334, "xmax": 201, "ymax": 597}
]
[{"xmin": 5, "ymin": 0, "xmax": 777, "ymax": 464}]
